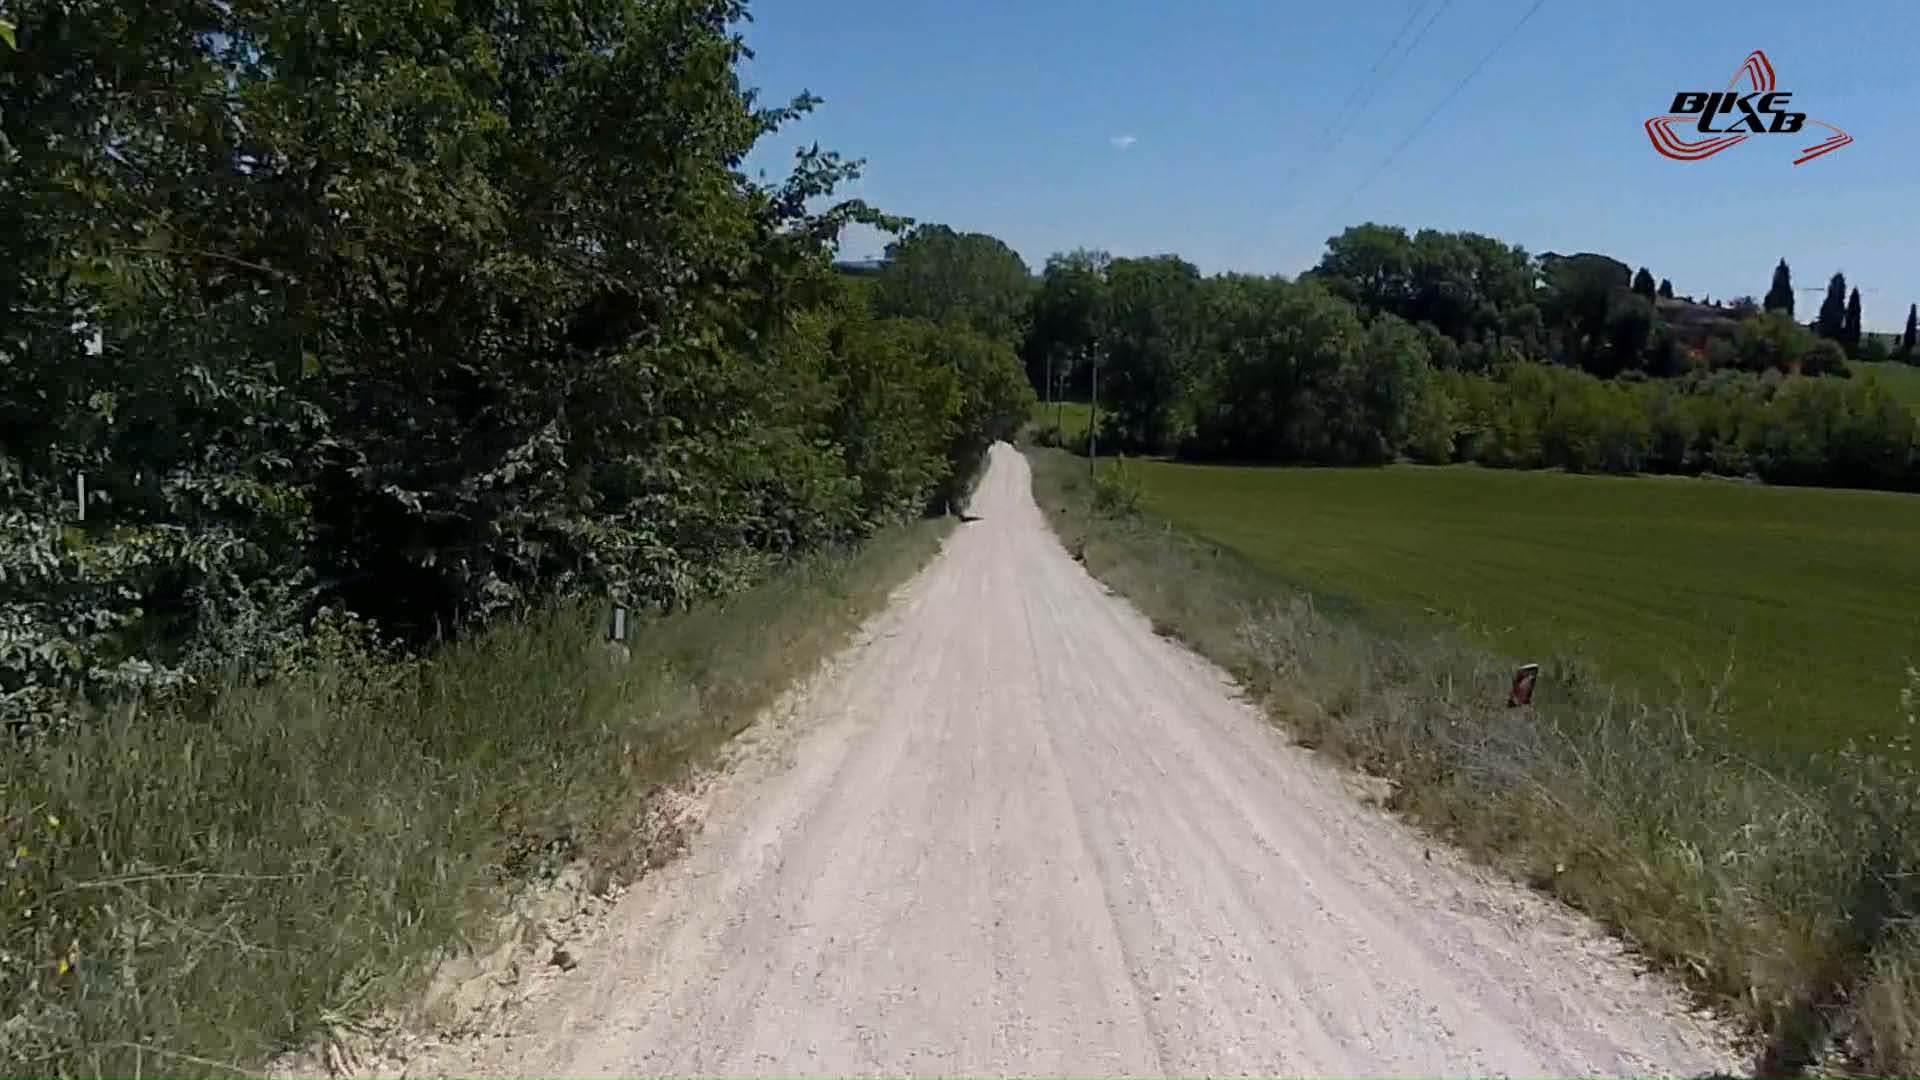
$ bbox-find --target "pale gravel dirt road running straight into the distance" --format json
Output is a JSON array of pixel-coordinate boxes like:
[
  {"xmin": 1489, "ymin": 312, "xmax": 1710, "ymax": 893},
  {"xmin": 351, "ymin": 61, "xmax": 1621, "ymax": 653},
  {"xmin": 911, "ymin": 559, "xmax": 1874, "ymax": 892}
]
[{"xmin": 420, "ymin": 446, "xmax": 1738, "ymax": 1076}]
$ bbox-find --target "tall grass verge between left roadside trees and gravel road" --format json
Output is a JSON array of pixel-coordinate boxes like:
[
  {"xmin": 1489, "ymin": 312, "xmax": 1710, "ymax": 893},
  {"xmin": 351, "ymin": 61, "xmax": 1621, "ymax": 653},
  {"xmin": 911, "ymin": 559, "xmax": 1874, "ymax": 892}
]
[{"xmin": 0, "ymin": 521, "xmax": 947, "ymax": 1076}]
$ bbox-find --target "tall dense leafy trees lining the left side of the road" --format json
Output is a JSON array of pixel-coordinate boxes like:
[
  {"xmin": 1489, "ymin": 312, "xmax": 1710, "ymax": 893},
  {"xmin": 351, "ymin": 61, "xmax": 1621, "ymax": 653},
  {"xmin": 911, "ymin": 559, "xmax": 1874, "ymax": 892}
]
[{"xmin": 0, "ymin": 0, "xmax": 1031, "ymax": 721}]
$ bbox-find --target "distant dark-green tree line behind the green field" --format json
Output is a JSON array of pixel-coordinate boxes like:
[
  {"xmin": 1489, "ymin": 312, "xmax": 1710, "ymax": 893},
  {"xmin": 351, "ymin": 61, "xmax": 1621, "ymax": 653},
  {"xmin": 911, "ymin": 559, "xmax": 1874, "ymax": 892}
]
[{"xmin": 1023, "ymin": 225, "xmax": 1920, "ymax": 488}]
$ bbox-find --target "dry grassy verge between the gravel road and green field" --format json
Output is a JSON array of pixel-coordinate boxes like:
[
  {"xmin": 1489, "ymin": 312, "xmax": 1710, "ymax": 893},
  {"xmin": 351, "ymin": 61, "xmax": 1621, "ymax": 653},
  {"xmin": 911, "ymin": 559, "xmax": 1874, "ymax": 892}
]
[{"xmin": 1029, "ymin": 450, "xmax": 1920, "ymax": 1074}]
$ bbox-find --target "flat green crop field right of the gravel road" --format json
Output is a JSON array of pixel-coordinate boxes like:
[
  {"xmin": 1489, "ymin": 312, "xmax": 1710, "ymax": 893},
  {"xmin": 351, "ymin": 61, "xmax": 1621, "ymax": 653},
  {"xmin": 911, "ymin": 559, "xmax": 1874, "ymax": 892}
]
[{"xmin": 1139, "ymin": 461, "xmax": 1920, "ymax": 748}]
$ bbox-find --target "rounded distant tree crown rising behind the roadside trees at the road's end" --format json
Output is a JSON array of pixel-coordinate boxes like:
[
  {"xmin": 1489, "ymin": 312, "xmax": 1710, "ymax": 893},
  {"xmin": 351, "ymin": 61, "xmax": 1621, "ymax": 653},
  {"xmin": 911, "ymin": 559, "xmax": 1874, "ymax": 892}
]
[{"xmin": 874, "ymin": 225, "xmax": 1033, "ymax": 344}]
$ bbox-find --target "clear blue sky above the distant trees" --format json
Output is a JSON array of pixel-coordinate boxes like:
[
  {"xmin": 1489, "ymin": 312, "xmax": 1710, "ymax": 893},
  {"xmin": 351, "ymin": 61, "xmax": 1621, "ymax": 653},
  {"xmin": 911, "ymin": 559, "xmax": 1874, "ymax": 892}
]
[{"xmin": 743, "ymin": 0, "xmax": 1920, "ymax": 329}]
